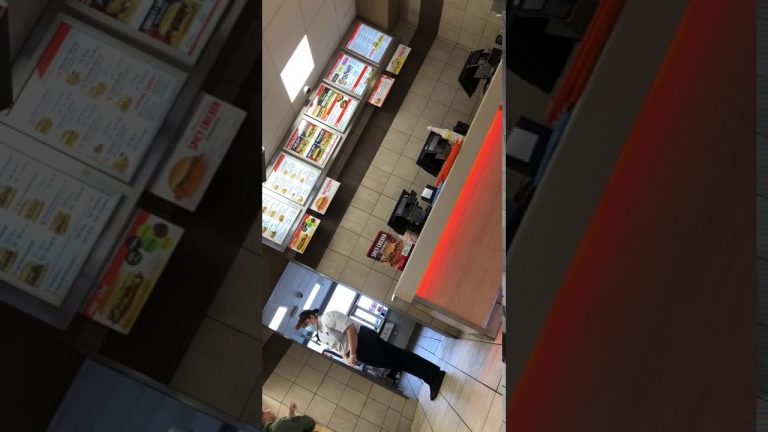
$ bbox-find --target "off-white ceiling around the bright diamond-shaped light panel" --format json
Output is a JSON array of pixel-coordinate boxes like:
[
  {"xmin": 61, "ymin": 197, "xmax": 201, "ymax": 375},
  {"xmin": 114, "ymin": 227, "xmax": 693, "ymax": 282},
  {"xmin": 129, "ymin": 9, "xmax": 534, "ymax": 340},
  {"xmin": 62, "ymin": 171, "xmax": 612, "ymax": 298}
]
[{"xmin": 261, "ymin": 0, "xmax": 356, "ymax": 164}]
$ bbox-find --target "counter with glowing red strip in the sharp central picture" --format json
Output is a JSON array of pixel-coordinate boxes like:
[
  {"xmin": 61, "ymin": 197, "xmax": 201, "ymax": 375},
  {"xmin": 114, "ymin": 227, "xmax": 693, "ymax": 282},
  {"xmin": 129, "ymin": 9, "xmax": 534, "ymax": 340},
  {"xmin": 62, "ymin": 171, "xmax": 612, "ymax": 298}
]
[{"xmin": 394, "ymin": 68, "xmax": 504, "ymax": 337}]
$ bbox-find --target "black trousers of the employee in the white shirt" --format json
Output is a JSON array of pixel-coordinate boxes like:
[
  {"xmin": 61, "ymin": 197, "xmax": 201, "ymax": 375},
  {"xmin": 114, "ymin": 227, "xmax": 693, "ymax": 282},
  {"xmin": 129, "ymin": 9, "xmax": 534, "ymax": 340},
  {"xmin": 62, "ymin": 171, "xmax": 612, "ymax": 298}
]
[{"xmin": 357, "ymin": 326, "xmax": 440, "ymax": 384}]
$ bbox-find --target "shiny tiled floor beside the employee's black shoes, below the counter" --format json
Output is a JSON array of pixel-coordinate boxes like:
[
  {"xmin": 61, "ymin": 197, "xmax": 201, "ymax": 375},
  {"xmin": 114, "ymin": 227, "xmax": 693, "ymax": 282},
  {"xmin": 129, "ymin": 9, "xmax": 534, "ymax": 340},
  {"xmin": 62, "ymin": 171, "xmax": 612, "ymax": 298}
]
[{"xmin": 406, "ymin": 328, "xmax": 504, "ymax": 432}]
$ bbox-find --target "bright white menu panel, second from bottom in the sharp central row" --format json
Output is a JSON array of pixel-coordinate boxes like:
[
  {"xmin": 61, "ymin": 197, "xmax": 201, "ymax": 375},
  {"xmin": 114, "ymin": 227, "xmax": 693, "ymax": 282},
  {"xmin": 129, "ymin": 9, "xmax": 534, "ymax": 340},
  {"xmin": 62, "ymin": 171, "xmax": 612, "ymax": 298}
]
[{"xmin": 264, "ymin": 153, "xmax": 321, "ymax": 205}]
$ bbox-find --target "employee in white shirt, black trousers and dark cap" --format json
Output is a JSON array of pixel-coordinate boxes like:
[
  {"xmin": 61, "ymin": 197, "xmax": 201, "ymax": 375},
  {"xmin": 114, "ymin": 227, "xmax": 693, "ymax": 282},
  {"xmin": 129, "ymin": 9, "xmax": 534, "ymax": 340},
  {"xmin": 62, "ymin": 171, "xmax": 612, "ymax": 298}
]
[{"xmin": 296, "ymin": 309, "xmax": 445, "ymax": 400}]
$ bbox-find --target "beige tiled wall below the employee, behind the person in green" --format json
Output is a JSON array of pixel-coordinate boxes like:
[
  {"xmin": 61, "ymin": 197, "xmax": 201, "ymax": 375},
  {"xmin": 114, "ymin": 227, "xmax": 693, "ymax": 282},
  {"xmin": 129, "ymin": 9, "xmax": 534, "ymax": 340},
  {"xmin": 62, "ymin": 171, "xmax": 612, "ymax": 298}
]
[{"xmin": 258, "ymin": 344, "xmax": 418, "ymax": 432}]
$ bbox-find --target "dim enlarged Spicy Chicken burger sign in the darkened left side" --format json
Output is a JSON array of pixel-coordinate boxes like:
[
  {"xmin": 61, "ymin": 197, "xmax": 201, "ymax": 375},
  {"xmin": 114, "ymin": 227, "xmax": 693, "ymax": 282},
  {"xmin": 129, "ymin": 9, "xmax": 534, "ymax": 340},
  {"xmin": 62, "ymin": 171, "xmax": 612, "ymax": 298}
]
[{"xmin": 152, "ymin": 94, "xmax": 245, "ymax": 211}]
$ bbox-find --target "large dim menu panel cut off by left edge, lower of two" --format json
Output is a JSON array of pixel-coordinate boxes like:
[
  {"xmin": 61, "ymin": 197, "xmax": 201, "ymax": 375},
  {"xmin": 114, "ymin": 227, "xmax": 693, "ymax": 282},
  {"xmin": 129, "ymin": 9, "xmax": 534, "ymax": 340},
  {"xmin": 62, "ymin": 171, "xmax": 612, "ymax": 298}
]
[{"xmin": 0, "ymin": 144, "xmax": 119, "ymax": 306}]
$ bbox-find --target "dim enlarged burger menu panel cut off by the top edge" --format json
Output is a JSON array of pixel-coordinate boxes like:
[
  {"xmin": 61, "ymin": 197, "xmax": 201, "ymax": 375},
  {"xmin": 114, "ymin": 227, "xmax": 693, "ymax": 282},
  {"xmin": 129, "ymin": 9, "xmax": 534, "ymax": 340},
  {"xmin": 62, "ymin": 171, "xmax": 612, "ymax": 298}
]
[{"xmin": 79, "ymin": 0, "xmax": 226, "ymax": 55}]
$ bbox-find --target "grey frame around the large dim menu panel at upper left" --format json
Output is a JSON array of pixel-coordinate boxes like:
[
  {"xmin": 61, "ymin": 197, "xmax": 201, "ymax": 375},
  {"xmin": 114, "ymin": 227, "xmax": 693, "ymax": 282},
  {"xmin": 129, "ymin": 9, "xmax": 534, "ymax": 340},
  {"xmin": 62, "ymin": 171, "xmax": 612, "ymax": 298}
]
[{"xmin": 0, "ymin": 13, "xmax": 188, "ymax": 183}]
